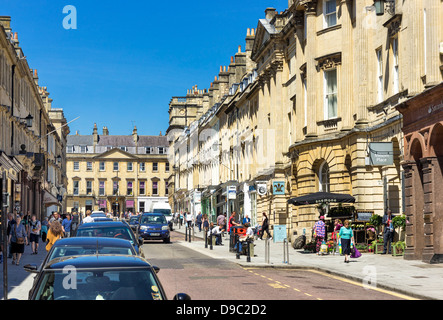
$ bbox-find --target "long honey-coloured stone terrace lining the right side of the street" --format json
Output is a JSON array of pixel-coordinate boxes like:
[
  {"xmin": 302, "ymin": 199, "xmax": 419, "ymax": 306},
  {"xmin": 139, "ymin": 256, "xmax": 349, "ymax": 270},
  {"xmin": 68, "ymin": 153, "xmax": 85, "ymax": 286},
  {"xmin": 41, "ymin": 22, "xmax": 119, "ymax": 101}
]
[{"xmin": 169, "ymin": 0, "xmax": 443, "ymax": 264}]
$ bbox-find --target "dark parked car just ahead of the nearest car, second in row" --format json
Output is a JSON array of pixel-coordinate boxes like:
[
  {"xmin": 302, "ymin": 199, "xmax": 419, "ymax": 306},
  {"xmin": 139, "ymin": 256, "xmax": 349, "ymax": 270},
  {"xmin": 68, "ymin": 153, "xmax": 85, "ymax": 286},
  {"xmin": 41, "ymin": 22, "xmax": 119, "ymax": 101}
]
[{"xmin": 24, "ymin": 237, "xmax": 137, "ymax": 297}]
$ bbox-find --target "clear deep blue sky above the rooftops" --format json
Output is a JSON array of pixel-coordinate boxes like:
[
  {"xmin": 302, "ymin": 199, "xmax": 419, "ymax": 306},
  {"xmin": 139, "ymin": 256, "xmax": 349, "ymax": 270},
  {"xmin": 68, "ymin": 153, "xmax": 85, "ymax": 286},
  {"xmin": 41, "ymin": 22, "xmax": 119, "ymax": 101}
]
[{"xmin": 0, "ymin": 0, "xmax": 288, "ymax": 135}]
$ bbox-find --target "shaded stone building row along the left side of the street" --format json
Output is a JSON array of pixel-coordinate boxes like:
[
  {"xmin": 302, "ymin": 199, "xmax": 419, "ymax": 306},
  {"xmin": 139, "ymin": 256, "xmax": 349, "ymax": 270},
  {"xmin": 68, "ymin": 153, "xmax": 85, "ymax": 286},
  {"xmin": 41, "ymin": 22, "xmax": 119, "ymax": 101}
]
[{"xmin": 0, "ymin": 16, "xmax": 69, "ymax": 219}]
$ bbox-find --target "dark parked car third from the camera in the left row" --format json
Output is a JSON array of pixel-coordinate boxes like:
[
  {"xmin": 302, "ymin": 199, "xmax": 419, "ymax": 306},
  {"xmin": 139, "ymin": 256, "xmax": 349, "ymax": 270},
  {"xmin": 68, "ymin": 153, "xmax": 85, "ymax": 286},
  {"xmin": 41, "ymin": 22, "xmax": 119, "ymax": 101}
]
[{"xmin": 75, "ymin": 221, "xmax": 143, "ymax": 256}]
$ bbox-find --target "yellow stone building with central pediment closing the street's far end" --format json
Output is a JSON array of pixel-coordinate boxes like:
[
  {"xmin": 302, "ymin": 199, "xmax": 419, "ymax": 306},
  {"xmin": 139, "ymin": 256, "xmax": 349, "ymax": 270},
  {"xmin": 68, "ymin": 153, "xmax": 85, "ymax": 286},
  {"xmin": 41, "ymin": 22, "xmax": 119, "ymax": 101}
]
[{"xmin": 66, "ymin": 125, "xmax": 171, "ymax": 214}]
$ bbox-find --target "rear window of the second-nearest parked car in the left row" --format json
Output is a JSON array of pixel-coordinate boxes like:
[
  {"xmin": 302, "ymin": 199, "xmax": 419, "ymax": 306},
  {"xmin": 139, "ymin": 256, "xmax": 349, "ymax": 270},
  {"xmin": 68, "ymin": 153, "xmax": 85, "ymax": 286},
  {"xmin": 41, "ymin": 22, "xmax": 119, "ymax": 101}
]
[{"xmin": 48, "ymin": 245, "xmax": 136, "ymax": 261}]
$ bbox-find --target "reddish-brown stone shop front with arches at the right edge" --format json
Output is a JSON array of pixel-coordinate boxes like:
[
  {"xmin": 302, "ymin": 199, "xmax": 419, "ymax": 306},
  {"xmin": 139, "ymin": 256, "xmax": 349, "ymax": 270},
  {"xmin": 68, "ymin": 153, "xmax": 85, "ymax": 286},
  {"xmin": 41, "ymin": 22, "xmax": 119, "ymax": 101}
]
[{"xmin": 397, "ymin": 83, "xmax": 443, "ymax": 263}]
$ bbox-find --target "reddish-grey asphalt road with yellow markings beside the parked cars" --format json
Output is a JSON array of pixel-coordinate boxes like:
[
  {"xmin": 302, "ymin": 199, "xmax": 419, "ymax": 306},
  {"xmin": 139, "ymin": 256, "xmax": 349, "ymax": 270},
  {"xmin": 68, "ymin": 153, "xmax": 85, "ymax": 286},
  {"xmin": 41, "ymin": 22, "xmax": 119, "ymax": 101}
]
[{"xmin": 143, "ymin": 232, "xmax": 412, "ymax": 301}]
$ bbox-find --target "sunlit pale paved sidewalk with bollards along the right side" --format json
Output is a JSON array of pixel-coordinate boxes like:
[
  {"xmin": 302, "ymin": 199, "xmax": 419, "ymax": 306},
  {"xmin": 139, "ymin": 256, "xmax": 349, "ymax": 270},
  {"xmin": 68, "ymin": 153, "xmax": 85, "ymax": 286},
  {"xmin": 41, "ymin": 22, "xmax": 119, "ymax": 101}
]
[{"xmin": 174, "ymin": 226, "xmax": 443, "ymax": 300}]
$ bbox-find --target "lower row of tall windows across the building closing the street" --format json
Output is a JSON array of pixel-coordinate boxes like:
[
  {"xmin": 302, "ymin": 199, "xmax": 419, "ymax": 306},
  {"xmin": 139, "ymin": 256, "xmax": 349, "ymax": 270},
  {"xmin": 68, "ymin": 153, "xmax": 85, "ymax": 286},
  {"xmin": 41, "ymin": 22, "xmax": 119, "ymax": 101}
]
[{"xmin": 72, "ymin": 180, "xmax": 168, "ymax": 196}]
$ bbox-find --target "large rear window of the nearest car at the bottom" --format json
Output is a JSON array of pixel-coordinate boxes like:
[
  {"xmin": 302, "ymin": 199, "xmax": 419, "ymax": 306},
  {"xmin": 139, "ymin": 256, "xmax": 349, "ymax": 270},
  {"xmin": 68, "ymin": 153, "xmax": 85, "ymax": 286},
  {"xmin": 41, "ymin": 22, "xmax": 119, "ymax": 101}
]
[{"xmin": 35, "ymin": 268, "xmax": 165, "ymax": 300}]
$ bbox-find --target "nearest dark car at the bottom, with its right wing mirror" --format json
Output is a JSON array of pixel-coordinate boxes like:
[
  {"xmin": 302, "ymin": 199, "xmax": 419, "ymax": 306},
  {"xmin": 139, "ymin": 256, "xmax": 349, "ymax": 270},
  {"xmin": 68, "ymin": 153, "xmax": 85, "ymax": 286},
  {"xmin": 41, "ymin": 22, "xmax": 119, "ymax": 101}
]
[{"xmin": 29, "ymin": 255, "xmax": 190, "ymax": 300}]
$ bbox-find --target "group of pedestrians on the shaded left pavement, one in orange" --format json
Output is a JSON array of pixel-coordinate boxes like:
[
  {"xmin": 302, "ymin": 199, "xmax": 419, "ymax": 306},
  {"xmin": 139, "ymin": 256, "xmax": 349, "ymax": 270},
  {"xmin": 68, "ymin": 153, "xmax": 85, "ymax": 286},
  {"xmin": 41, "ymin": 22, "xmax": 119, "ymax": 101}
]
[{"xmin": 0, "ymin": 212, "xmax": 71, "ymax": 266}]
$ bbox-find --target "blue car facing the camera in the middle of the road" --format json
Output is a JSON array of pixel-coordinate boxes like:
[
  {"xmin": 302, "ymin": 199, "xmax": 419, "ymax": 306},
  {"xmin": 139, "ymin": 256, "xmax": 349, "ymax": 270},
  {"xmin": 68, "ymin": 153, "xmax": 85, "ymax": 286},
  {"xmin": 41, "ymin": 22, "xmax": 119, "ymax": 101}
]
[{"xmin": 139, "ymin": 213, "xmax": 171, "ymax": 243}]
